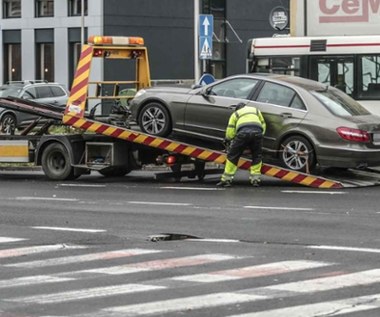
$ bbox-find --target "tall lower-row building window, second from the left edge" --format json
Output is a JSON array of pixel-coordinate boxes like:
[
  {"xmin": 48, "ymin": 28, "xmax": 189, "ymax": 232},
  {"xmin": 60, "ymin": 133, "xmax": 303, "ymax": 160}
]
[{"xmin": 36, "ymin": 43, "xmax": 54, "ymax": 81}]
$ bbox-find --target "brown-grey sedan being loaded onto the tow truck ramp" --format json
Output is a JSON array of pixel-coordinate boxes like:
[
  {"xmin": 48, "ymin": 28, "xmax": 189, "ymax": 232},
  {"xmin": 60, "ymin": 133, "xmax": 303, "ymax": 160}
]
[{"xmin": 130, "ymin": 74, "xmax": 380, "ymax": 171}]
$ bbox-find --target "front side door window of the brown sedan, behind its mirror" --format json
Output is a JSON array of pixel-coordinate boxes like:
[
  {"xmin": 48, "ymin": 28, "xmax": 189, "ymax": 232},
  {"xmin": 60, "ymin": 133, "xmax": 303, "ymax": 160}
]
[{"xmin": 210, "ymin": 78, "xmax": 258, "ymax": 99}]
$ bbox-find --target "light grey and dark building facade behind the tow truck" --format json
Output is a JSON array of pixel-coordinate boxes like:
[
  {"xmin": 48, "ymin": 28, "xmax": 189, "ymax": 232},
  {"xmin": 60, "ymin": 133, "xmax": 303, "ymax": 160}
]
[{"xmin": 0, "ymin": 0, "xmax": 289, "ymax": 88}]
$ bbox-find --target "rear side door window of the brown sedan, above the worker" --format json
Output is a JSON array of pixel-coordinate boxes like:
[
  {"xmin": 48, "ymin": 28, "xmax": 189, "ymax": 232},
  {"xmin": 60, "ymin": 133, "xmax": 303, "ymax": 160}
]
[{"xmin": 256, "ymin": 82, "xmax": 300, "ymax": 108}]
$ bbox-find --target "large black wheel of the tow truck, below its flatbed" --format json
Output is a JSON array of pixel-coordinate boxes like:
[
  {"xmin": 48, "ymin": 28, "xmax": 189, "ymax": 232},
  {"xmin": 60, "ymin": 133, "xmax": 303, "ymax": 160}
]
[{"xmin": 42, "ymin": 143, "xmax": 76, "ymax": 180}]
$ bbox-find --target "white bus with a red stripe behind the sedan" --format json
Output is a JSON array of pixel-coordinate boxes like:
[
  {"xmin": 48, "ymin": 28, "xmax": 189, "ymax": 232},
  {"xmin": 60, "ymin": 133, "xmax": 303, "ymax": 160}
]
[{"xmin": 247, "ymin": 35, "xmax": 380, "ymax": 115}]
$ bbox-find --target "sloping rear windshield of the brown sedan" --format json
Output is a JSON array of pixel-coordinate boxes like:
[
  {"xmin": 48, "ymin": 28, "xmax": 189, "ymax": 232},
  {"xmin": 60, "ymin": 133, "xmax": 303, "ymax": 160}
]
[{"xmin": 310, "ymin": 89, "xmax": 370, "ymax": 116}]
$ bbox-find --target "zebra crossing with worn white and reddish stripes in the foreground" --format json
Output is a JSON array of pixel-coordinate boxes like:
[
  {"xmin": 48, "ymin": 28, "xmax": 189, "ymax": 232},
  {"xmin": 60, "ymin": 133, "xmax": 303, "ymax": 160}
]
[{"xmin": 0, "ymin": 233, "xmax": 380, "ymax": 317}]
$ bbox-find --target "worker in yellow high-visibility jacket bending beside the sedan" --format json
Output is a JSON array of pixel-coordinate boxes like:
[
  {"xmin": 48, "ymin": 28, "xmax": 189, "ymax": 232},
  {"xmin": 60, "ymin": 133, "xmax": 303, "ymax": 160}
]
[{"xmin": 217, "ymin": 103, "xmax": 266, "ymax": 187}]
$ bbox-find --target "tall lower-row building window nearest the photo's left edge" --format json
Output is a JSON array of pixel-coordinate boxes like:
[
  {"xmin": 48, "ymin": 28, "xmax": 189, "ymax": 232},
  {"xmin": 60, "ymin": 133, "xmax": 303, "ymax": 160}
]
[{"xmin": 4, "ymin": 44, "xmax": 21, "ymax": 82}]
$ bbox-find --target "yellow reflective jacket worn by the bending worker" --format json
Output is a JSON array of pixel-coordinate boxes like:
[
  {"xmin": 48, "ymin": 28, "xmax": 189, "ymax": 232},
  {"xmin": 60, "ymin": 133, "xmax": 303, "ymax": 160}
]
[{"xmin": 226, "ymin": 106, "xmax": 266, "ymax": 140}]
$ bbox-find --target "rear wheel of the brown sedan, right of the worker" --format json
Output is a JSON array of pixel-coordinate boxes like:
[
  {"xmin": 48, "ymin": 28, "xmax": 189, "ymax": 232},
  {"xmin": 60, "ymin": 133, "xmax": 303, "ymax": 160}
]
[{"xmin": 280, "ymin": 136, "xmax": 316, "ymax": 172}]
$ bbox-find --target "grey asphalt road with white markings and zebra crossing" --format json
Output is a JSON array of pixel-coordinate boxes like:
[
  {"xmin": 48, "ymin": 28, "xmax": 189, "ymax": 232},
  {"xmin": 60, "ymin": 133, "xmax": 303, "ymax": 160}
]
[{"xmin": 0, "ymin": 171, "xmax": 380, "ymax": 317}]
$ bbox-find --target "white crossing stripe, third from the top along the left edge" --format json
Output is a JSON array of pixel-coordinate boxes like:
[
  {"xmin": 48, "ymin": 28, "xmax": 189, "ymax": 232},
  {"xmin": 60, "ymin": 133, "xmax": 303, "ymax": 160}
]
[{"xmin": 4, "ymin": 249, "xmax": 162, "ymax": 268}]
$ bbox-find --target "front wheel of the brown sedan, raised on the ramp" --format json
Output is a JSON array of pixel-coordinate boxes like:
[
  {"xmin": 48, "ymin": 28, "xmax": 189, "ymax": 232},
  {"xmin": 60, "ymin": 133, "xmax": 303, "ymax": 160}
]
[{"xmin": 138, "ymin": 102, "xmax": 172, "ymax": 137}]
